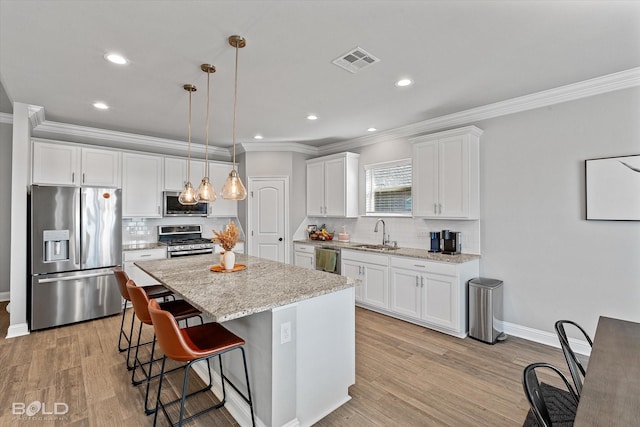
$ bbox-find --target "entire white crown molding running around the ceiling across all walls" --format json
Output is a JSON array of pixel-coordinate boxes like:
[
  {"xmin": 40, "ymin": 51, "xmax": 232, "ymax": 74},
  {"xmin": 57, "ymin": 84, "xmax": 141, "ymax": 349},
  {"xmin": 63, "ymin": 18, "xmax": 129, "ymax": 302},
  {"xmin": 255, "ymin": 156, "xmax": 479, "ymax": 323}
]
[{"xmin": 6, "ymin": 67, "xmax": 640, "ymax": 159}]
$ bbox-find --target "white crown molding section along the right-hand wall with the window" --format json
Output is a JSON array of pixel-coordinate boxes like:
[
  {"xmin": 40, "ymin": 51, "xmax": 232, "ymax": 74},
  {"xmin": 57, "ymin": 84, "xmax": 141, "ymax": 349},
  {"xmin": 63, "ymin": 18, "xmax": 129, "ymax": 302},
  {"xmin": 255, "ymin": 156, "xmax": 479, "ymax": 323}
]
[{"xmin": 320, "ymin": 67, "xmax": 640, "ymax": 154}]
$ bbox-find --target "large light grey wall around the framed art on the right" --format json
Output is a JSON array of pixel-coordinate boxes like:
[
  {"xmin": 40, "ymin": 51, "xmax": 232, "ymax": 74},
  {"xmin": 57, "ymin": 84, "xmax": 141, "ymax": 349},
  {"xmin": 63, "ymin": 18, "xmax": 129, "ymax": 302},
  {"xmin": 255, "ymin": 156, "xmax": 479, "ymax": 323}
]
[{"xmin": 477, "ymin": 88, "xmax": 640, "ymax": 336}]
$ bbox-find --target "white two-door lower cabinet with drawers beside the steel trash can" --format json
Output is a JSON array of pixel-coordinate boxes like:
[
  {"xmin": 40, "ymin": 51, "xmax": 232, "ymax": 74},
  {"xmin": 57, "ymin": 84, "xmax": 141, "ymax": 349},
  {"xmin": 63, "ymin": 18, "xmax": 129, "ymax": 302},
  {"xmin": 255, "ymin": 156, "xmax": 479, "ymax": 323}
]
[{"xmin": 390, "ymin": 256, "xmax": 479, "ymax": 337}]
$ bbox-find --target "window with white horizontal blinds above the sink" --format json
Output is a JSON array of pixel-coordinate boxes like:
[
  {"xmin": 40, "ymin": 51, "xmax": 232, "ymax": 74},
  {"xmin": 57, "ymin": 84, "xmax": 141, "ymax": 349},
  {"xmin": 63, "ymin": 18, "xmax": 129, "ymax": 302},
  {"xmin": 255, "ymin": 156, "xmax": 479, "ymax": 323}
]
[{"xmin": 364, "ymin": 159, "xmax": 411, "ymax": 216}]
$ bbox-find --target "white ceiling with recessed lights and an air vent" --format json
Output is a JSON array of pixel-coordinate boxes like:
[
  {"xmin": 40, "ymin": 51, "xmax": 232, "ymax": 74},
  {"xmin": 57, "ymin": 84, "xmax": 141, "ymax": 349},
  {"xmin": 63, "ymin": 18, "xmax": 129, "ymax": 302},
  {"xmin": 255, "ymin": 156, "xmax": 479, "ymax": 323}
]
[{"xmin": 0, "ymin": 0, "xmax": 640, "ymax": 147}]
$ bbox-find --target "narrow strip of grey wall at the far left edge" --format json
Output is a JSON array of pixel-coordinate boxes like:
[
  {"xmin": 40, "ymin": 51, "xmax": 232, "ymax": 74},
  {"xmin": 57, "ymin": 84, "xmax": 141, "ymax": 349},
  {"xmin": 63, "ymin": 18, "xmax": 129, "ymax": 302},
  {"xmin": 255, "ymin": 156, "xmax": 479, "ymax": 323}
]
[{"xmin": 0, "ymin": 123, "xmax": 13, "ymax": 301}]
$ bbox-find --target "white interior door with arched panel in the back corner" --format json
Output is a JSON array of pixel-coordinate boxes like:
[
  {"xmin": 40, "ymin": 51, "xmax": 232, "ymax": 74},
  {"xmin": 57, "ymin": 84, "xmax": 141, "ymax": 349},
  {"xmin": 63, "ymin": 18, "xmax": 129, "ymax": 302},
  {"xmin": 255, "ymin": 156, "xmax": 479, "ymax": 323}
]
[{"xmin": 248, "ymin": 177, "xmax": 289, "ymax": 262}]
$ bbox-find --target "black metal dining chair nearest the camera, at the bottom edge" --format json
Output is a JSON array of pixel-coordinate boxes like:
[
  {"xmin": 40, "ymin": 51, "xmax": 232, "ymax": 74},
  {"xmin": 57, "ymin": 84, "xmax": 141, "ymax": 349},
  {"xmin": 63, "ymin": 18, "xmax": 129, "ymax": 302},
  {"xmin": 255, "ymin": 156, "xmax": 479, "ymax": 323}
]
[{"xmin": 522, "ymin": 363, "xmax": 578, "ymax": 427}]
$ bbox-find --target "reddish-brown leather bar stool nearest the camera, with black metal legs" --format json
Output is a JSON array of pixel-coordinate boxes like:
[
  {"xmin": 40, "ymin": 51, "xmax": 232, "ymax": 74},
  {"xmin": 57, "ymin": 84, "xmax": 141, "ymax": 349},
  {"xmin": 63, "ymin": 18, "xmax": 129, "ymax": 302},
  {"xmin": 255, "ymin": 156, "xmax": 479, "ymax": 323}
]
[{"xmin": 149, "ymin": 301, "xmax": 256, "ymax": 426}]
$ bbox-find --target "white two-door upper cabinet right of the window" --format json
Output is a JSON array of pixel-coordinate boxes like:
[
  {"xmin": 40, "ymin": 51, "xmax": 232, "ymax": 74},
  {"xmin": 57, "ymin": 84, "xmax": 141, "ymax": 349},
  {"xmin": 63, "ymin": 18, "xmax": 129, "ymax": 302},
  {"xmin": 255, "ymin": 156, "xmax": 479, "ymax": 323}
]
[{"xmin": 409, "ymin": 126, "xmax": 482, "ymax": 219}]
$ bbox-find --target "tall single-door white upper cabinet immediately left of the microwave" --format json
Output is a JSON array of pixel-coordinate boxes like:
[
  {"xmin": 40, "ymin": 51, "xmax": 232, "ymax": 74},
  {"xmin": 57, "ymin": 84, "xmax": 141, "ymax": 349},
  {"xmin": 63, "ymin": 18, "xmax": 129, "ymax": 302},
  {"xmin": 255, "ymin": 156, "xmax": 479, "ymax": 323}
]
[{"xmin": 122, "ymin": 153, "xmax": 164, "ymax": 218}]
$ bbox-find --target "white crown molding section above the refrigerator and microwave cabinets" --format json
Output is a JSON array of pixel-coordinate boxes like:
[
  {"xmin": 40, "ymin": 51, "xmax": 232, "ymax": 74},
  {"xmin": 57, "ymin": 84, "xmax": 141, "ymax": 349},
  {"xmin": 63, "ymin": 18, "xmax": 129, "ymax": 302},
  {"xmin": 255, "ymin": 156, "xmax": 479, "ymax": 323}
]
[{"xmin": 34, "ymin": 121, "xmax": 231, "ymax": 159}]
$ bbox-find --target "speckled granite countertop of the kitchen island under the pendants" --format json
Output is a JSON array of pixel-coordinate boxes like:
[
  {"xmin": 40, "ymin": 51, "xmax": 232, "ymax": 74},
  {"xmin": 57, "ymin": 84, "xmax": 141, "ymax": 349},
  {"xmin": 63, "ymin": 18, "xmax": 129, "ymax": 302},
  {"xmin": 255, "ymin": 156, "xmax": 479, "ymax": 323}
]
[{"xmin": 135, "ymin": 254, "xmax": 355, "ymax": 322}]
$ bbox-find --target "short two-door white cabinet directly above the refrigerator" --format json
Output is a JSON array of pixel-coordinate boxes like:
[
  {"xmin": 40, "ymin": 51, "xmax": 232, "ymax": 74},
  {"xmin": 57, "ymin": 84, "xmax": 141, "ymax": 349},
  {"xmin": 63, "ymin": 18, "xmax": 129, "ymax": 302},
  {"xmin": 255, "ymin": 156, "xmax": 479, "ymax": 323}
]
[{"xmin": 32, "ymin": 141, "xmax": 121, "ymax": 188}]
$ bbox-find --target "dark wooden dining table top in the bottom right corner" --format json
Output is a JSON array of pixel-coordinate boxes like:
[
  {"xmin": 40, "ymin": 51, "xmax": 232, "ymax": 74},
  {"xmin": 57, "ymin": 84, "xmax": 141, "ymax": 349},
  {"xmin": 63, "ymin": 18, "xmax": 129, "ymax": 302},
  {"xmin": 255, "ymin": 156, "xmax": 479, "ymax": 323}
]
[{"xmin": 574, "ymin": 316, "xmax": 640, "ymax": 427}]
